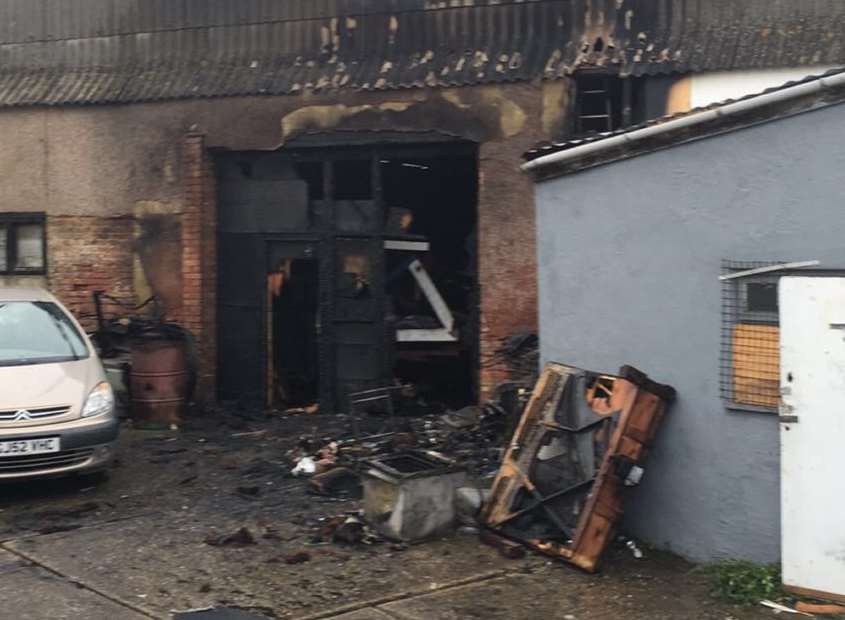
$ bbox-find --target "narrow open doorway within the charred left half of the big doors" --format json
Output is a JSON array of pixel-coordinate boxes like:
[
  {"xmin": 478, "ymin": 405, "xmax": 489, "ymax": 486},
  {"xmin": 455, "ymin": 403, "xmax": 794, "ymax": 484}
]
[{"xmin": 265, "ymin": 242, "xmax": 320, "ymax": 409}]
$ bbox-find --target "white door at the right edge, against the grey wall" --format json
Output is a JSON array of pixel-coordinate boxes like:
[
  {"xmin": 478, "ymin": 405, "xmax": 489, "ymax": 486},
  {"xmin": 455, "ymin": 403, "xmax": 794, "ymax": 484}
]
[{"xmin": 779, "ymin": 277, "xmax": 845, "ymax": 599}]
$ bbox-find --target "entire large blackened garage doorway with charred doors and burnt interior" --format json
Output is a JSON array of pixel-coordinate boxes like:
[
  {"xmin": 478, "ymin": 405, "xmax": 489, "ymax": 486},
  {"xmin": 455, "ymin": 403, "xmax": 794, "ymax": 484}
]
[{"xmin": 215, "ymin": 142, "xmax": 478, "ymax": 411}]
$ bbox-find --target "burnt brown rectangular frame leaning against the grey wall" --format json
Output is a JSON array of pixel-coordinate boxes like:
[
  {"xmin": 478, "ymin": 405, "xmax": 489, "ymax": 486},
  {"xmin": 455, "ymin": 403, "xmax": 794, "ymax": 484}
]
[{"xmin": 482, "ymin": 364, "xmax": 675, "ymax": 572}]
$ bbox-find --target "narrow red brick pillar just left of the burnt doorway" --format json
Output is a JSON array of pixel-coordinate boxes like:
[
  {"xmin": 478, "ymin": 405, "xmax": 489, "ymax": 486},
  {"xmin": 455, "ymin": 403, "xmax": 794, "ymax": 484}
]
[{"xmin": 181, "ymin": 134, "xmax": 217, "ymax": 401}]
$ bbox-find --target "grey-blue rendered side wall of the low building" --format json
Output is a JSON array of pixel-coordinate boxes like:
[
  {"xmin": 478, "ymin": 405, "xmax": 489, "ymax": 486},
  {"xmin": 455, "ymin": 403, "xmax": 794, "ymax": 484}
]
[{"xmin": 537, "ymin": 105, "xmax": 845, "ymax": 561}]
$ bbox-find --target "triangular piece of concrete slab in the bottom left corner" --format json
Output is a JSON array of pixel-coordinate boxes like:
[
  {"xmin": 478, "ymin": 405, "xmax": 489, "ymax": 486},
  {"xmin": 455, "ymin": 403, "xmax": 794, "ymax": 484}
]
[{"xmin": 0, "ymin": 550, "xmax": 147, "ymax": 620}]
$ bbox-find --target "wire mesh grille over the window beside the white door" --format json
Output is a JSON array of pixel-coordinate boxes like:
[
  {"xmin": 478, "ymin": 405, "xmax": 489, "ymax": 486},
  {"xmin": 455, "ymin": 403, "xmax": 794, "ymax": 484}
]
[{"xmin": 719, "ymin": 261, "xmax": 780, "ymax": 410}]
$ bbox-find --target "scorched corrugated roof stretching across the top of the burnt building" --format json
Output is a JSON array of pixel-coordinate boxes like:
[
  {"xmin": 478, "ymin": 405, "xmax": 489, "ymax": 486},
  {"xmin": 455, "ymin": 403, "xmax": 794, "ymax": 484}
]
[{"xmin": 0, "ymin": 0, "xmax": 845, "ymax": 106}]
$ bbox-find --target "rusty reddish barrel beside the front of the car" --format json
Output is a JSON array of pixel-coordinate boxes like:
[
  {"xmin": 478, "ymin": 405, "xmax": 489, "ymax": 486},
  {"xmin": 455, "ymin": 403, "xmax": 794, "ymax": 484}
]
[{"xmin": 129, "ymin": 339, "xmax": 189, "ymax": 429}]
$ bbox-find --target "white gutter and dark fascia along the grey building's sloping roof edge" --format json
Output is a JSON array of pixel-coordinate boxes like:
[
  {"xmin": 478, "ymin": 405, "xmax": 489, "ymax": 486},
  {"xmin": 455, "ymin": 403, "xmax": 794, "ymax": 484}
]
[{"xmin": 520, "ymin": 72, "xmax": 845, "ymax": 180}]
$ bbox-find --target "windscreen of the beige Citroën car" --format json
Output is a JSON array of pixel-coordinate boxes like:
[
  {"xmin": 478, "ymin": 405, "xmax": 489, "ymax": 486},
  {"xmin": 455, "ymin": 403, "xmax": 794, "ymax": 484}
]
[{"xmin": 0, "ymin": 301, "xmax": 89, "ymax": 366}]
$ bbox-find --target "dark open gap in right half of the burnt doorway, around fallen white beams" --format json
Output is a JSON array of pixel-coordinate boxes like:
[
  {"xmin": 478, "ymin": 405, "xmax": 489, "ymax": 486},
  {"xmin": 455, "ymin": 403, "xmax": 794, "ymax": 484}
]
[{"xmin": 379, "ymin": 156, "xmax": 478, "ymax": 409}]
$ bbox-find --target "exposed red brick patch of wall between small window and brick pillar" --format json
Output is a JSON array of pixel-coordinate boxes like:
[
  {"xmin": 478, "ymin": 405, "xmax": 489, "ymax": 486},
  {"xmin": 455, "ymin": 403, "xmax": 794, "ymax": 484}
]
[{"xmin": 47, "ymin": 215, "xmax": 135, "ymax": 330}]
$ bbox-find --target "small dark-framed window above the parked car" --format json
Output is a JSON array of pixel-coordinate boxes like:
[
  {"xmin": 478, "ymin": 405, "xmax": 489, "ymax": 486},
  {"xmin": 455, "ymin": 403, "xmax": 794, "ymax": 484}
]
[{"xmin": 0, "ymin": 213, "xmax": 46, "ymax": 275}]
